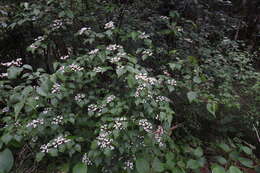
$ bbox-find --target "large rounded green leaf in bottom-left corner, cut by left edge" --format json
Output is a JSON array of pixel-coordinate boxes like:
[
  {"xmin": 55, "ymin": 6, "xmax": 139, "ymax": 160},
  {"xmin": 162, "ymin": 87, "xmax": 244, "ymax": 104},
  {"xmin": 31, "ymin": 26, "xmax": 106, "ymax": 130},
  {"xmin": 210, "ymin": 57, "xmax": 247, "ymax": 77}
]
[{"xmin": 0, "ymin": 148, "xmax": 14, "ymax": 172}]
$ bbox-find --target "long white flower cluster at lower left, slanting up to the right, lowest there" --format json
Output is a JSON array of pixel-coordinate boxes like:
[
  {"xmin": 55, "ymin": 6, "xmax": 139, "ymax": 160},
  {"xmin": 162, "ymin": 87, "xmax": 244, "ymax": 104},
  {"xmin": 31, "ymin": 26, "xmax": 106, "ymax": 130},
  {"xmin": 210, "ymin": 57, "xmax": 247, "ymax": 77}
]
[{"xmin": 40, "ymin": 135, "xmax": 71, "ymax": 153}]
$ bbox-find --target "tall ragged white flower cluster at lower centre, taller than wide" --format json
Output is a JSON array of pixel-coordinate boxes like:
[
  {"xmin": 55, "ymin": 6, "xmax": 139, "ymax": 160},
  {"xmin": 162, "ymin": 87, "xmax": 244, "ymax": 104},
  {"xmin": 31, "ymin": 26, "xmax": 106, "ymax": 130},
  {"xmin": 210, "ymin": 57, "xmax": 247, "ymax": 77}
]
[{"xmin": 97, "ymin": 124, "xmax": 115, "ymax": 150}]
